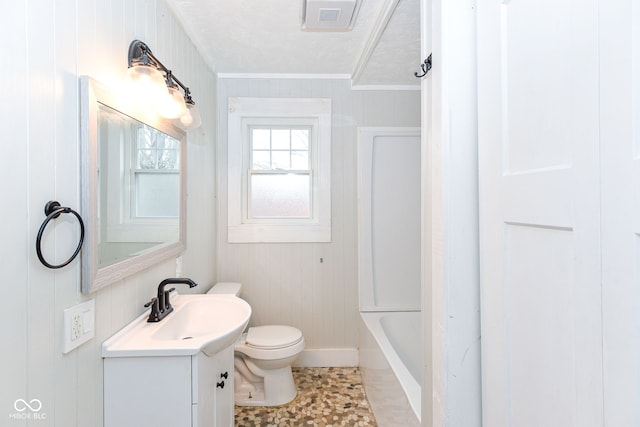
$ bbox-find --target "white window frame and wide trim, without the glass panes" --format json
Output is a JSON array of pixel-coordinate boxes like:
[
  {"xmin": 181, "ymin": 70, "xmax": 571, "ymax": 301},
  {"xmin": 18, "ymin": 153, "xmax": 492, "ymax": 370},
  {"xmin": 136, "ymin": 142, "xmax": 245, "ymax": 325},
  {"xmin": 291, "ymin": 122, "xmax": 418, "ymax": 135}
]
[{"xmin": 227, "ymin": 98, "xmax": 331, "ymax": 243}]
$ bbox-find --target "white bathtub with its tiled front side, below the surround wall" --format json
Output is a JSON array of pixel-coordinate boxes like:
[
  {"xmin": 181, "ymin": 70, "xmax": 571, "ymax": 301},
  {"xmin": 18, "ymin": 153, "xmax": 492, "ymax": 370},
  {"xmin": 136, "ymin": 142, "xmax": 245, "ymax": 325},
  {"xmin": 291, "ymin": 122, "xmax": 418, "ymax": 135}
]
[{"xmin": 359, "ymin": 311, "xmax": 422, "ymax": 427}]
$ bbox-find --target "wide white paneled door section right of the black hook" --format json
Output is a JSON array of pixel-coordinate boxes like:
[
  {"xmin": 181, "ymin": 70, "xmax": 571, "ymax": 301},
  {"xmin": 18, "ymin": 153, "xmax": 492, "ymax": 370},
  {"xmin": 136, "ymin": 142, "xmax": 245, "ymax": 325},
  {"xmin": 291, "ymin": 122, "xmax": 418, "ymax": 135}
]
[{"xmin": 478, "ymin": 0, "xmax": 603, "ymax": 427}]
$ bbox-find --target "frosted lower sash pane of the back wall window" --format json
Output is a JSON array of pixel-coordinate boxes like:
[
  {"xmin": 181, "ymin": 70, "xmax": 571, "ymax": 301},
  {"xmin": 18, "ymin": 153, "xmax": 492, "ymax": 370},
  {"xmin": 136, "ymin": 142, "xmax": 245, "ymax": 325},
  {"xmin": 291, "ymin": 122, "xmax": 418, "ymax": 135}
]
[{"xmin": 249, "ymin": 174, "xmax": 311, "ymax": 218}]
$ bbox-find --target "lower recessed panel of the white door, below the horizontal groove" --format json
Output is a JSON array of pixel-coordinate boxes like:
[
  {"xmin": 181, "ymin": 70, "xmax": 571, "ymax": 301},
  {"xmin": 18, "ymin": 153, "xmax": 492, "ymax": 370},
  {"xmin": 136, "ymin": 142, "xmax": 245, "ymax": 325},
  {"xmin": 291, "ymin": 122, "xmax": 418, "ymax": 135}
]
[{"xmin": 500, "ymin": 224, "xmax": 579, "ymax": 426}]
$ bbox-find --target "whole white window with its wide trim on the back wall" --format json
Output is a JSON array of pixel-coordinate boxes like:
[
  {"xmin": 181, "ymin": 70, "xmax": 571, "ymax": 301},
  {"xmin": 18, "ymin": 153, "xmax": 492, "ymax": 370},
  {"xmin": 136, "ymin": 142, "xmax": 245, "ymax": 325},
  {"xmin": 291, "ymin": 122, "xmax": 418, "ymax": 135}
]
[{"xmin": 228, "ymin": 98, "xmax": 331, "ymax": 242}]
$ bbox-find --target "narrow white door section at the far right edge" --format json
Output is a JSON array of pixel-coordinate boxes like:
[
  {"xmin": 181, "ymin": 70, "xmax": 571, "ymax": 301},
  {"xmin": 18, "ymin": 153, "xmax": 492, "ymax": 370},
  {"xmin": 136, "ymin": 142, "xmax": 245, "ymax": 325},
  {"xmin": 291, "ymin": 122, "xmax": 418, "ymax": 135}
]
[{"xmin": 599, "ymin": 0, "xmax": 640, "ymax": 427}]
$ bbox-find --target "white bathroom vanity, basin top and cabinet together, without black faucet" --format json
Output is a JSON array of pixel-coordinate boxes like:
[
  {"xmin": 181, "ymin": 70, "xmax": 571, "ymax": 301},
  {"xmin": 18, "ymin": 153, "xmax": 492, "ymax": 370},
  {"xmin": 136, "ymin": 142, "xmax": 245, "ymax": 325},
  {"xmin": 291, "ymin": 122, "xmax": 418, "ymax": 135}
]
[{"xmin": 102, "ymin": 294, "xmax": 251, "ymax": 427}]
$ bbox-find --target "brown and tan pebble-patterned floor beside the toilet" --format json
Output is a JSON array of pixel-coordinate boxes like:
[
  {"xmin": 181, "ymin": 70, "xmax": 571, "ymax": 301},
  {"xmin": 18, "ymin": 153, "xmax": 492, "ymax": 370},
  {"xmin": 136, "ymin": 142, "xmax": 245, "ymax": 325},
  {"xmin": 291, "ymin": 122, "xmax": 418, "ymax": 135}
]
[{"xmin": 235, "ymin": 368, "xmax": 377, "ymax": 427}]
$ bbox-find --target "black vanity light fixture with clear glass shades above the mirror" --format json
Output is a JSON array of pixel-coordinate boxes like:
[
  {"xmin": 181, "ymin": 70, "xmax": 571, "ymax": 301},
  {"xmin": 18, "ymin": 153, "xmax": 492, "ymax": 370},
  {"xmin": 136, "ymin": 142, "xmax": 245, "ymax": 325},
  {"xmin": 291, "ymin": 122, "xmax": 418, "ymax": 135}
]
[{"xmin": 126, "ymin": 40, "xmax": 202, "ymax": 129}]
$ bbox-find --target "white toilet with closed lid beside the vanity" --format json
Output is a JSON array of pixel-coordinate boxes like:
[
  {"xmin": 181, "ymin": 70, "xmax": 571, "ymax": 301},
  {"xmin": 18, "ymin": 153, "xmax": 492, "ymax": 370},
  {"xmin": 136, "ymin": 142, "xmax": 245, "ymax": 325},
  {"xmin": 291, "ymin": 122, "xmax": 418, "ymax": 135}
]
[{"xmin": 207, "ymin": 282, "xmax": 304, "ymax": 406}]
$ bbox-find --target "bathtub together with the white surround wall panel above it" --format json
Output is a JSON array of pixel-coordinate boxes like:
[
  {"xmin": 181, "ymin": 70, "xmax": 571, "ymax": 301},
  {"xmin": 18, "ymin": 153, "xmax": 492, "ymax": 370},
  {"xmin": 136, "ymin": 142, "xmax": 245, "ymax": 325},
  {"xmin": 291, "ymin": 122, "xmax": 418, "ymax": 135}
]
[{"xmin": 358, "ymin": 127, "xmax": 422, "ymax": 427}]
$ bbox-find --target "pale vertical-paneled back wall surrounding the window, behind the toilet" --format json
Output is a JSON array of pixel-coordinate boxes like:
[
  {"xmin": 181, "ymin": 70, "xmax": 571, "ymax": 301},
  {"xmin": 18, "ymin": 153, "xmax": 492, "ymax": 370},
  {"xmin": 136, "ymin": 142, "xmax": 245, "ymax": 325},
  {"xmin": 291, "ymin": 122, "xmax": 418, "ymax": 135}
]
[{"xmin": 217, "ymin": 76, "xmax": 420, "ymax": 363}]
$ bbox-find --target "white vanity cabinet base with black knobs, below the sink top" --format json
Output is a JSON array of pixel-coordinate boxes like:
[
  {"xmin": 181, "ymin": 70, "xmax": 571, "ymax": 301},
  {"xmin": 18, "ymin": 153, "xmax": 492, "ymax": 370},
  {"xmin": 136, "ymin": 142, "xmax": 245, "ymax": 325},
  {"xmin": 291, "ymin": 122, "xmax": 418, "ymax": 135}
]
[{"xmin": 104, "ymin": 346, "xmax": 234, "ymax": 427}]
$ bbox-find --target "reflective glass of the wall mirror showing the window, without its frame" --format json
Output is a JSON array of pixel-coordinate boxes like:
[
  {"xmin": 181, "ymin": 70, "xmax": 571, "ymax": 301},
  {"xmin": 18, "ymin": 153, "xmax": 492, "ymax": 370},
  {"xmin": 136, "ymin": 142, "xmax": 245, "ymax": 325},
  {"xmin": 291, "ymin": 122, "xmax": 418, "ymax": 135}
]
[{"xmin": 98, "ymin": 107, "xmax": 182, "ymax": 251}]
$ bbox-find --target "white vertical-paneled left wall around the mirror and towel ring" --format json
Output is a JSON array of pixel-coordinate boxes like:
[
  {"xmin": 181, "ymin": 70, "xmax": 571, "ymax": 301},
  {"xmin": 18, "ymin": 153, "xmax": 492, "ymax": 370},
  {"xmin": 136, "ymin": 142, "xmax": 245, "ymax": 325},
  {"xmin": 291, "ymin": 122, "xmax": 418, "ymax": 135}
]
[{"xmin": 0, "ymin": 0, "xmax": 216, "ymax": 427}]
